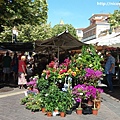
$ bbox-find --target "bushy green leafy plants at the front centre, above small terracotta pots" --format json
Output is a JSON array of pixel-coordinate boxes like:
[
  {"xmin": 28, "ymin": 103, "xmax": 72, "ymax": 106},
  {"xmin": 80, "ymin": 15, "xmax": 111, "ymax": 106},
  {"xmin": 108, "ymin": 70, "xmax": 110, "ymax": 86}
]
[{"xmin": 40, "ymin": 84, "xmax": 74, "ymax": 112}]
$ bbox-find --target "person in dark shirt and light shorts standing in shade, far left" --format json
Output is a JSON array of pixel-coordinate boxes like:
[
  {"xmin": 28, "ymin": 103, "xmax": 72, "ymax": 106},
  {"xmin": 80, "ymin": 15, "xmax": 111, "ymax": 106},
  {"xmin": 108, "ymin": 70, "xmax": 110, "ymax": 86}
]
[{"xmin": 2, "ymin": 51, "xmax": 12, "ymax": 81}]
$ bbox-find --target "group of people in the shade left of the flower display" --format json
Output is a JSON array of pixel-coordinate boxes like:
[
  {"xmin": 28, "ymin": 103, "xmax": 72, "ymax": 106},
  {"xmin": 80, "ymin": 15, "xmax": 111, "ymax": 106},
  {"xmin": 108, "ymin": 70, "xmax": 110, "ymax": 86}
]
[{"xmin": 0, "ymin": 51, "xmax": 34, "ymax": 88}]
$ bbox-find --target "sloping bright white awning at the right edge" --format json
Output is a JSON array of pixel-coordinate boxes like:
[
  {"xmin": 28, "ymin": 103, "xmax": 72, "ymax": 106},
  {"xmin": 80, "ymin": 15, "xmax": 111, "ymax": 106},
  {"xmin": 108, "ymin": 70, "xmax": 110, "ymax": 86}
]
[{"xmin": 85, "ymin": 32, "xmax": 120, "ymax": 47}]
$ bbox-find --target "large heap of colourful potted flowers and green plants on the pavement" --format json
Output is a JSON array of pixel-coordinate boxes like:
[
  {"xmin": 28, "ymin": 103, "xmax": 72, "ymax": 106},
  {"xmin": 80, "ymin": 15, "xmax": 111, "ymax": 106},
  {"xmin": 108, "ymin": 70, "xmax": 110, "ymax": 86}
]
[{"xmin": 21, "ymin": 45, "xmax": 103, "ymax": 117}]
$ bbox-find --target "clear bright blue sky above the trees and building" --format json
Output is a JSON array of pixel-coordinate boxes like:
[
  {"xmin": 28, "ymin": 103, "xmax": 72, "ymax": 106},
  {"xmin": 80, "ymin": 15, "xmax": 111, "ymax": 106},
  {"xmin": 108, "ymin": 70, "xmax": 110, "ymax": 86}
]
[{"xmin": 47, "ymin": 0, "xmax": 120, "ymax": 28}]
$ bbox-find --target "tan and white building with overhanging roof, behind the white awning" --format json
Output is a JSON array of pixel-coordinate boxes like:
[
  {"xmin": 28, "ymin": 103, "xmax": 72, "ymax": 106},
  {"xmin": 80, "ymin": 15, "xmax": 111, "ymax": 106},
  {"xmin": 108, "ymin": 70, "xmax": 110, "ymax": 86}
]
[{"xmin": 81, "ymin": 14, "xmax": 110, "ymax": 42}]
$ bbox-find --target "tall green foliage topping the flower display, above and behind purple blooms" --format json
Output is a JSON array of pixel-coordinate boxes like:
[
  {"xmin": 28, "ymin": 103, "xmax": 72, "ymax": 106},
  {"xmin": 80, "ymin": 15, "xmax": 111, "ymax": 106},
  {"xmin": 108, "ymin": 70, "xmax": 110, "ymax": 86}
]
[{"xmin": 70, "ymin": 45, "xmax": 103, "ymax": 85}]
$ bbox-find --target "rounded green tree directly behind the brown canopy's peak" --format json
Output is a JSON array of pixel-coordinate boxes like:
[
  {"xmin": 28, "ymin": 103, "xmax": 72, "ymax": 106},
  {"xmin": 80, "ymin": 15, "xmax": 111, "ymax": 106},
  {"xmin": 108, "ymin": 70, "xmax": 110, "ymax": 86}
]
[{"xmin": 52, "ymin": 24, "xmax": 77, "ymax": 38}]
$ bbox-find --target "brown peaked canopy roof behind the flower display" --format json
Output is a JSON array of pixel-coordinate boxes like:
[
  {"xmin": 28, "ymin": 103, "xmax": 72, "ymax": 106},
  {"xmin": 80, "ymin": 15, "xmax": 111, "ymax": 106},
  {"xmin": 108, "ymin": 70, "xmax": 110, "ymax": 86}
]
[{"xmin": 35, "ymin": 31, "xmax": 87, "ymax": 52}]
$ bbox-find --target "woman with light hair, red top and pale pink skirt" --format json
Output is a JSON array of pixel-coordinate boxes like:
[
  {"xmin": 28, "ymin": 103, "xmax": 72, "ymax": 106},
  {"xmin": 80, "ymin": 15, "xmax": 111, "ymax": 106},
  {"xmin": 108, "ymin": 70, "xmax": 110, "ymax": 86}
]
[{"xmin": 18, "ymin": 56, "xmax": 27, "ymax": 89}]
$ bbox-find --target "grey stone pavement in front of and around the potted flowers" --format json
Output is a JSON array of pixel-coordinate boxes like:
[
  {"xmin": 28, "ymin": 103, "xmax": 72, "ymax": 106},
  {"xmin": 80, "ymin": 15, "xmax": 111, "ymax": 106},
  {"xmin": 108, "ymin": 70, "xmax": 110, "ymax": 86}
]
[{"xmin": 0, "ymin": 88, "xmax": 120, "ymax": 120}]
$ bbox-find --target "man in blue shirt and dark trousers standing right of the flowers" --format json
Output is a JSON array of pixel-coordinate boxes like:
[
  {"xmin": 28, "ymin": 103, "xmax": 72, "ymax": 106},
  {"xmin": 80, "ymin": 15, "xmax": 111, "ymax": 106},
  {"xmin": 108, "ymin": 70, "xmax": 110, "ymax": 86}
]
[{"xmin": 105, "ymin": 52, "xmax": 115, "ymax": 92}]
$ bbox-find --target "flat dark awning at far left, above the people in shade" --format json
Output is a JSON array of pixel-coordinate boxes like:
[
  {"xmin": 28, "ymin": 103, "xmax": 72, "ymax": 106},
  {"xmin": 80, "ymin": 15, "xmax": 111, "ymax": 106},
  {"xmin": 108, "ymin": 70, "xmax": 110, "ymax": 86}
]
[{"xmin": 0, "ymin": 42, "xmax": 34, "ymax": 51}]
